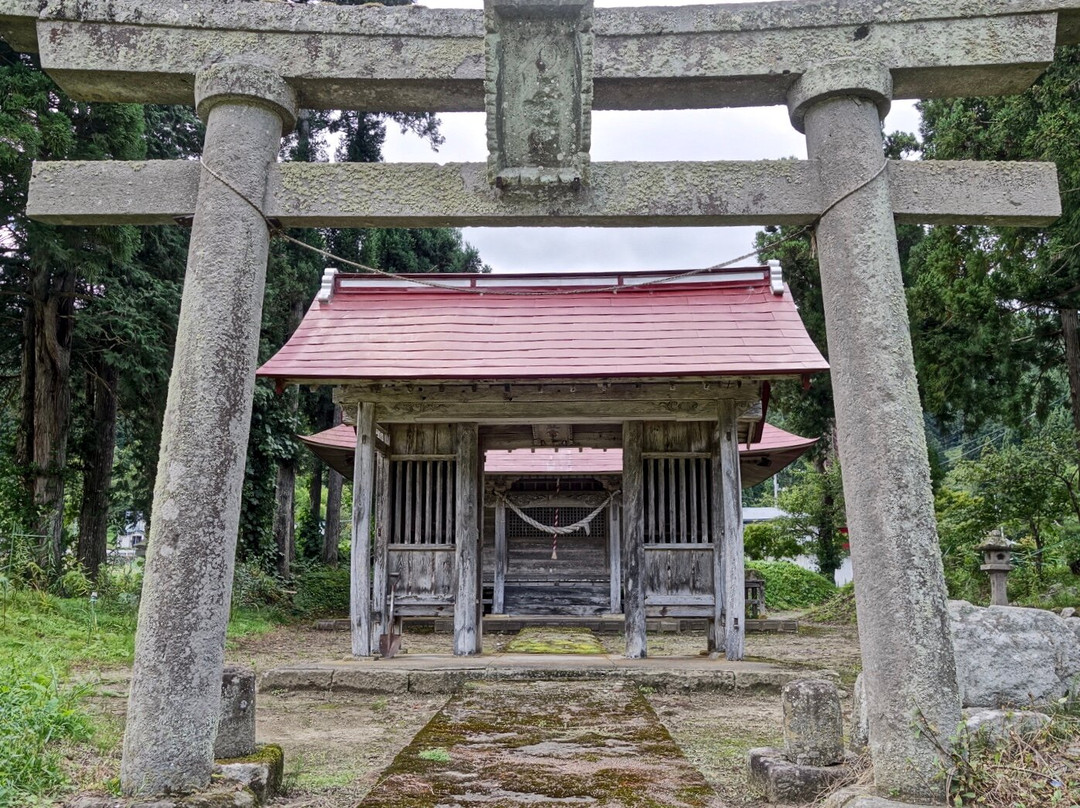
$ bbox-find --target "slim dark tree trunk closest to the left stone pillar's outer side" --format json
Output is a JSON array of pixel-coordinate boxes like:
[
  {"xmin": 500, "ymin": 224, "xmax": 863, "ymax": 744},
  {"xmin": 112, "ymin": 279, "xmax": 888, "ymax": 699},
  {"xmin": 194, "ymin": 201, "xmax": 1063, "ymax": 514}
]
[{"xmin": 78, "ymin": 361, "xmax": 120, "ymax": 580}]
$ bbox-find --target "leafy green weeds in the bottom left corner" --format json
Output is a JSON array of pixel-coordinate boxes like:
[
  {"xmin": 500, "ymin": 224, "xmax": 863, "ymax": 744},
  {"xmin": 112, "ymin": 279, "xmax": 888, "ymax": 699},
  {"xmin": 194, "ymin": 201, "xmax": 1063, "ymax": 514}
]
[{"xmin": 0, "ymin": 668, "xmax": 91, "ymax": 806}]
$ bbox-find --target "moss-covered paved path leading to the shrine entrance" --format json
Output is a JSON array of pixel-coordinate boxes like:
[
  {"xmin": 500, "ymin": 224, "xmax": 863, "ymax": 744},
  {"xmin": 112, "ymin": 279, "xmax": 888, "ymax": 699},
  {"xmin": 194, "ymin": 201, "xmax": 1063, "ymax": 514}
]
[{"xmin": 360, "ymin": 679, "xmax": 719, "ymax": 808}]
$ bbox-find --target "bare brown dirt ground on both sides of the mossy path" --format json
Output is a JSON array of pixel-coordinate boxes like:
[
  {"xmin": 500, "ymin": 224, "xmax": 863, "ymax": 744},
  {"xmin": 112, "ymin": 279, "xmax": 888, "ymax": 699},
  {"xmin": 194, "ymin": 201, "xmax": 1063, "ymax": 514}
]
[{"xmin": 72, "ymin": 627, "xmax": 860, "ymax": 808}]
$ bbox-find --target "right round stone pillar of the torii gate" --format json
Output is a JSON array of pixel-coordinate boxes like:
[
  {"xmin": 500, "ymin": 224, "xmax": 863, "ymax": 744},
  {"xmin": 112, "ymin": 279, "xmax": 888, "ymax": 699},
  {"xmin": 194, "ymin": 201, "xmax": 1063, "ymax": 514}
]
[{"xmin": 788, "ymin": 62, "xmax": 960, "ymax": 799}]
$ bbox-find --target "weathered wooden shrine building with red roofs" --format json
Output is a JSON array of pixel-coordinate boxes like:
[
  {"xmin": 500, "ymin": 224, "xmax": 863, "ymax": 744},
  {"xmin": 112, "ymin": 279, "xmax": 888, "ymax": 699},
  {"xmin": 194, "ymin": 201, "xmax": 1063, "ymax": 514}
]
[{"xmin": 259, "ymin": 264, "xmax": 827, "ymax": 659}]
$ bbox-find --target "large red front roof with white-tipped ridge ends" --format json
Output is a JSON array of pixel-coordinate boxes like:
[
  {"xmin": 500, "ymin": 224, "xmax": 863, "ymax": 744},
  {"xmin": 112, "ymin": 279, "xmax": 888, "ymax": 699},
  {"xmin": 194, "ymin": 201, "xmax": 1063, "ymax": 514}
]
[{"xmin": 258, "ymin": 265, "xmax": 828, "ymax": 385}]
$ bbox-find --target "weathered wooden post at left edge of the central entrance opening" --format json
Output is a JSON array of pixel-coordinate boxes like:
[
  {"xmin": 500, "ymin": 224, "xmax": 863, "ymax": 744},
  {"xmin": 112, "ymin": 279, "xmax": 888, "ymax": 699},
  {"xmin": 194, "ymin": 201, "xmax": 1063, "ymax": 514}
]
[{"xmin": 454, "ymin": 423, "xmax": 480, "ymax": 657}]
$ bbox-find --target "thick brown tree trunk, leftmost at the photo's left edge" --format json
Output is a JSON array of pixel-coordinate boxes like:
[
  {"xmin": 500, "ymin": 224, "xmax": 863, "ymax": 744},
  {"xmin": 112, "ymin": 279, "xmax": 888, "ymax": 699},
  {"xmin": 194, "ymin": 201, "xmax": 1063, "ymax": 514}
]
[{"xmin": 16, "ymin": 267, "xmax": 76, "ymax": 571}]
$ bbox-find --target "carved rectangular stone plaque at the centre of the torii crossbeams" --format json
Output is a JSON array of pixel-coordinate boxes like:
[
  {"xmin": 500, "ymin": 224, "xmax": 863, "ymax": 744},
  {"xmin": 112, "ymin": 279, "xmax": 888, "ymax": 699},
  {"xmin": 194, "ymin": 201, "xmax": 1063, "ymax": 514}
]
[{"xmin": 484, "ymin": 0, "xmax": 593, "ymax": 191}]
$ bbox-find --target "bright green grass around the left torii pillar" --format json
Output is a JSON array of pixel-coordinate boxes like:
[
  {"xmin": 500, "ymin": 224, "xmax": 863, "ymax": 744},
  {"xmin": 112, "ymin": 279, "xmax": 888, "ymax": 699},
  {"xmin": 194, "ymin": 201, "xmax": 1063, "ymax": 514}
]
[{"xmin": 0, "ymin": 589, "xmax": 280, "ymax": 808}]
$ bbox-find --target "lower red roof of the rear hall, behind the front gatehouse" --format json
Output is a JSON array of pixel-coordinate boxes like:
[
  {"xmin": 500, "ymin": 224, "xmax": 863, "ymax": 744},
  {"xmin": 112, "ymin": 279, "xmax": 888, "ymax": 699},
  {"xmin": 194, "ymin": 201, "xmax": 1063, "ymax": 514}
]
[{"xmin": 300, "ymin": 423, "xmax": 816, "ymax": 487}]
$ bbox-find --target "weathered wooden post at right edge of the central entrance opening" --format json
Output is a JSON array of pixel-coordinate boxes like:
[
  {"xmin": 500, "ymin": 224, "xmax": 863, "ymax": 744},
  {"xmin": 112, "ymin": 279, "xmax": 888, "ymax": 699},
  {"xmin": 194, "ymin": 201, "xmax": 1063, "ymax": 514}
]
[{"xmin": 622, "ymin": 421, "xmax": 647, "ymax": 659}]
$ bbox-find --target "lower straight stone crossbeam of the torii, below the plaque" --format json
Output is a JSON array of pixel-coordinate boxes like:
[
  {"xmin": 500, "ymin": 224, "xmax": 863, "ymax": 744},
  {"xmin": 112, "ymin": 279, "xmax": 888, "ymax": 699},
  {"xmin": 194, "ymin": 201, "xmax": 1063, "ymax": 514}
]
[{"xmin": 27, "ymin": 160, "xmax": 1061, "ymax": 227}]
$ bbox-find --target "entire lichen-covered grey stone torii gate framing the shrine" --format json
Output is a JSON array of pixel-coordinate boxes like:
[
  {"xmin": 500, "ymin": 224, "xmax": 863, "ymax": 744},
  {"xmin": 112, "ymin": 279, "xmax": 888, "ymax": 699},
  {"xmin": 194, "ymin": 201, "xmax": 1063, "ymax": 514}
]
[{"xmin": 0, "ymin": 0, "xmax": 1080, "ymax": 798}]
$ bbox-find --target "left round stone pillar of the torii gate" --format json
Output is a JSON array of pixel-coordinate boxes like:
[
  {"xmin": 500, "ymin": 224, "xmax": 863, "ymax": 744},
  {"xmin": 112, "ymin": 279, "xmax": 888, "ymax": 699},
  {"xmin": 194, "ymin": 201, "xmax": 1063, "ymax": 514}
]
[{"xmin": 120, "ymin": 63, "xmax": 296, "ymax": 794}]
